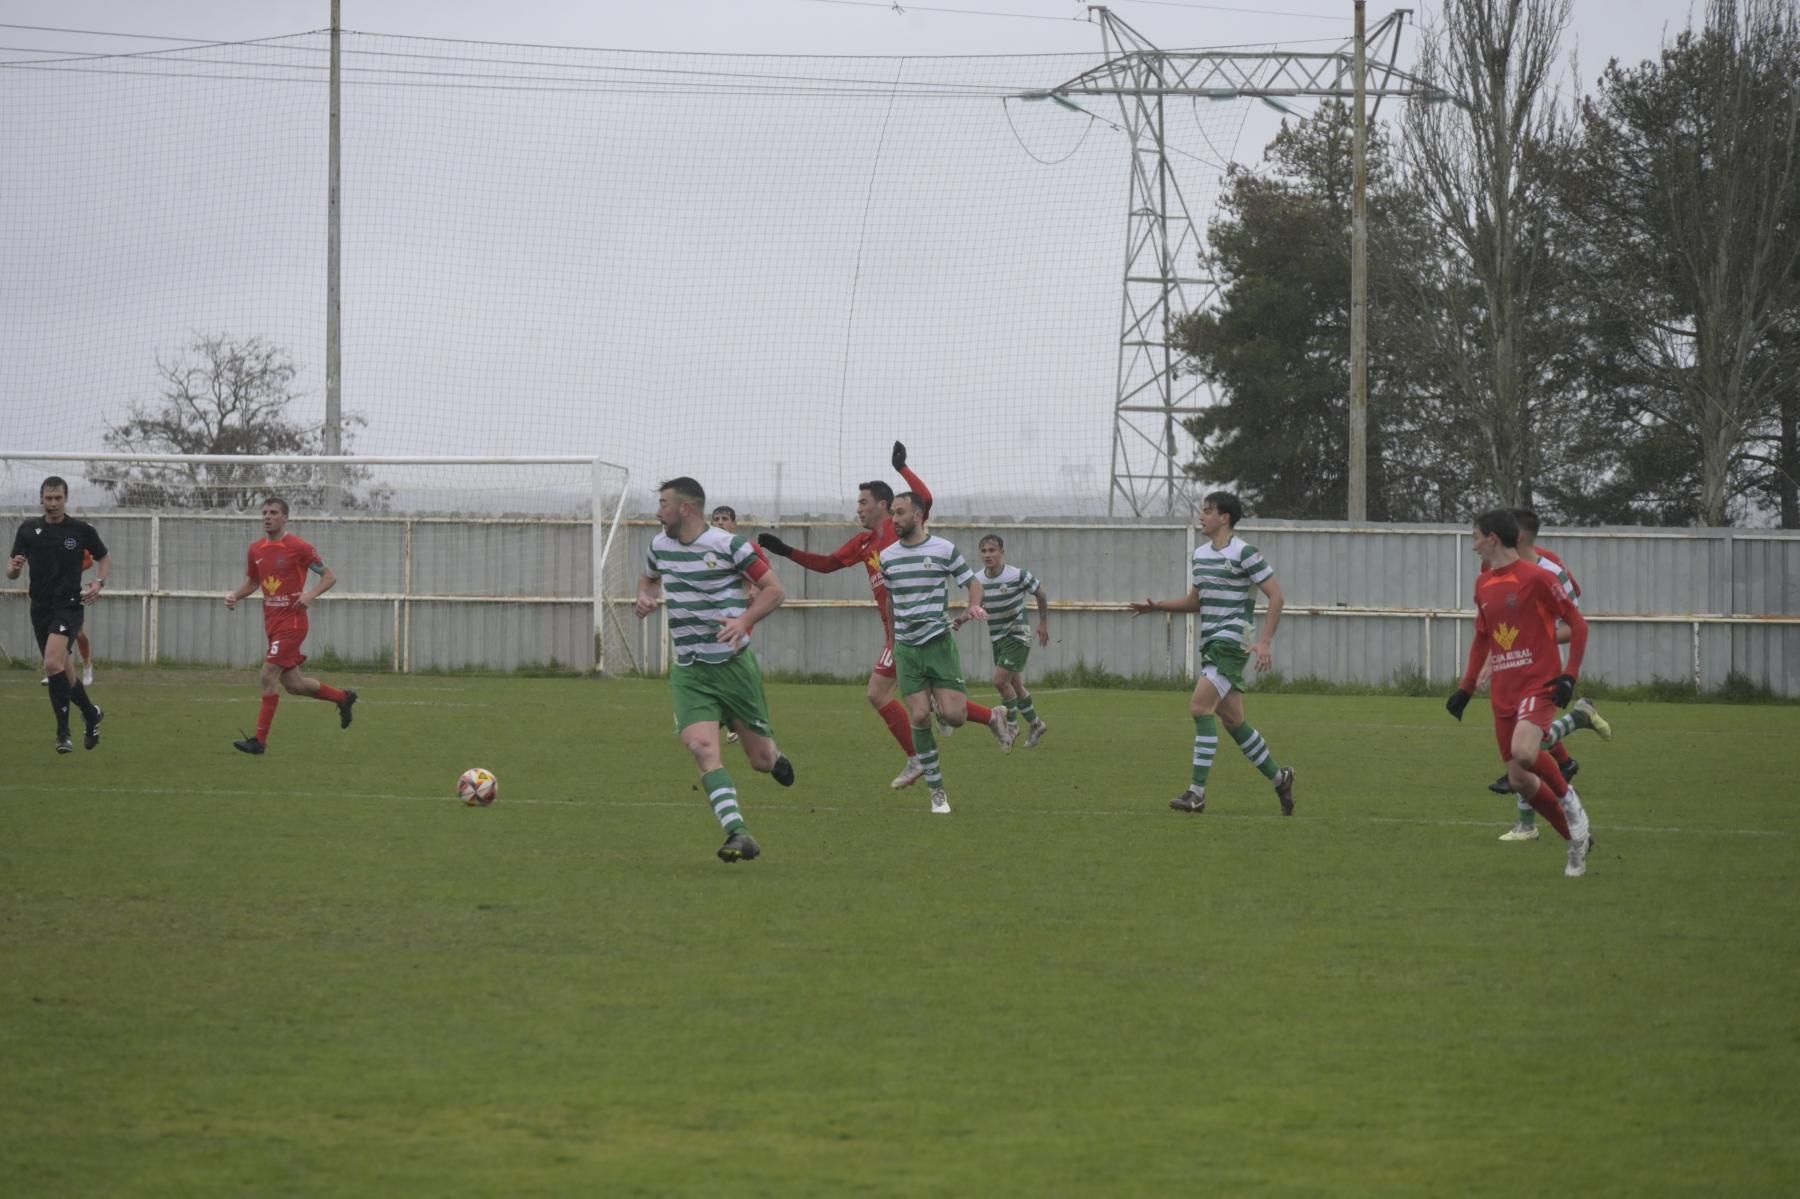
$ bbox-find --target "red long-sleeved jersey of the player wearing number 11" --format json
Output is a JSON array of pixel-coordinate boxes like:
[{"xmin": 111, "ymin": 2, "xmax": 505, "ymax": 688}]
[{"xmin": 1462, "ymin": 560, "xmax": 1588, "ymax": 713}]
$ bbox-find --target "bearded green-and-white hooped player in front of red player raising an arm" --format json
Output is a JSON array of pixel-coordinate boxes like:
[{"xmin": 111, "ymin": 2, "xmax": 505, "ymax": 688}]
[{"xmin": 880, "ymin": 491, "xmax": 1012, "ymax": 816}]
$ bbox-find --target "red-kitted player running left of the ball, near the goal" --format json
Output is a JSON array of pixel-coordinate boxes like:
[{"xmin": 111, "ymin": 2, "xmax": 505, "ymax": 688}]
[{"xmin": 225, "ymin": 497, "xmax": 356, "ymax": 754}]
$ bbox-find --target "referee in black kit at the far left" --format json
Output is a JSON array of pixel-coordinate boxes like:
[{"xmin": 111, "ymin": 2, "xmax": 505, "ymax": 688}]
[{"xmin": 5, "ymin": 475, "xmax": 112, "ymax": 754}]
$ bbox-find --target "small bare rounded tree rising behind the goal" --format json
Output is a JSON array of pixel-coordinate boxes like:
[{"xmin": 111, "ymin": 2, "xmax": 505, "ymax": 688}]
[{"xmin": 90, "ymin": 333, "xmax": 387, "ymax": 511}]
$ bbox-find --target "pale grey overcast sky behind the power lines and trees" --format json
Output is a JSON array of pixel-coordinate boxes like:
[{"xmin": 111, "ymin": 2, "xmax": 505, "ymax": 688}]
[{"xmin": 0, "ymin": 0, "xmax": 1688, "ymax": 515}]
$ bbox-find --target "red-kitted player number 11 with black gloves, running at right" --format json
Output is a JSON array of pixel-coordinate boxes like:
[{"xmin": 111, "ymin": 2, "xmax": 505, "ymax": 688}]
[{"xmin": 1444, "ymin": 509, "xmax": 1593, "ymax": 879}]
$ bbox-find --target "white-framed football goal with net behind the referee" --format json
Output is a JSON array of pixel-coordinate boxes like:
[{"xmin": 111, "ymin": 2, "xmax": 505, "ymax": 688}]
[{"xmin": 0, "ymin": 448, "xmax": 637, "ymax": 673}]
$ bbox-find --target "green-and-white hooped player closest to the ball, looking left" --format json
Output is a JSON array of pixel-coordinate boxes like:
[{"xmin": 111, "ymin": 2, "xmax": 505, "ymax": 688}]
[{"xmin": 637, "ymin": 475, "xmax": 794, "ymax": 862}]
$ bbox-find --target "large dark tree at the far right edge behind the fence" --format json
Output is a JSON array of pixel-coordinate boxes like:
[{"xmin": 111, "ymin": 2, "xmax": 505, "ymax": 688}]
[{"xmin": 1575, "ymin": 0, "xmax": 1800, "ymax": 526}]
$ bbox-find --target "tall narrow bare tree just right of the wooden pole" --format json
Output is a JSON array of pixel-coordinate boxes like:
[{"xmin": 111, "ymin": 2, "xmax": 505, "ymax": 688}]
[{"xmin": 1402, "ymin": 0, "xmax": 1570, "ymax": 504}]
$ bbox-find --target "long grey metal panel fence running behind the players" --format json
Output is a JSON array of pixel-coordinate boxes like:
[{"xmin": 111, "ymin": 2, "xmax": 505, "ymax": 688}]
[{"xmin": 0, "ymin": 513, "xmax": 1800, "ymax": 695}]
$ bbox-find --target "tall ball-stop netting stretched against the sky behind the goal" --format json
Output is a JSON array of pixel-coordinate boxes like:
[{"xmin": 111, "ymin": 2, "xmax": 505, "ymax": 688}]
[{"xmin": 0, "ymin": 32, "xmax": 1247, "ymax": 517}]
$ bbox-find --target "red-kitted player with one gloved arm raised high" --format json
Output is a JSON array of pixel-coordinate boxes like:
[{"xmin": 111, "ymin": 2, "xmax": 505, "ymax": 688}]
[{"xmin": 756, "ymin": 441, "xmax": 1013, "ymax": 789}]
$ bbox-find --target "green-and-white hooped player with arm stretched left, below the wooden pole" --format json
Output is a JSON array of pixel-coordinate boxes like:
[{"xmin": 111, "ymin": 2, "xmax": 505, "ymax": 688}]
[{"xmin": 1130, "ymin": 491, "xmax": 1294, "ymax": 816}]
